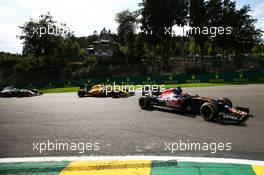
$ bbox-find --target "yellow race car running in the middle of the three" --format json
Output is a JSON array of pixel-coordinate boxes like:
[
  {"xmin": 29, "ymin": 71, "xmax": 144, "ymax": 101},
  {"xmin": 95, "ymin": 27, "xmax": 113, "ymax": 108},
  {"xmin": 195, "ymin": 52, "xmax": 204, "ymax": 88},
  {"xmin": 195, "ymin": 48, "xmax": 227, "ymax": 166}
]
[{"xmin": 77, "ymin": 84, "xmax": 135, "ymax": 98}]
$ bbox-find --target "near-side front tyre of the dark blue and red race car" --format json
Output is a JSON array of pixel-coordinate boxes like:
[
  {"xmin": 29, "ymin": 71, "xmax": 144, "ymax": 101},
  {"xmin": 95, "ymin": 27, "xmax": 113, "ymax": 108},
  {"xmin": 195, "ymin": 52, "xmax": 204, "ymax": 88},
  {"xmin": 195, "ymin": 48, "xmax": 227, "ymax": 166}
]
[{"xmin": 200, "ymin": 101, "xmax": 218, "ymax": 121}]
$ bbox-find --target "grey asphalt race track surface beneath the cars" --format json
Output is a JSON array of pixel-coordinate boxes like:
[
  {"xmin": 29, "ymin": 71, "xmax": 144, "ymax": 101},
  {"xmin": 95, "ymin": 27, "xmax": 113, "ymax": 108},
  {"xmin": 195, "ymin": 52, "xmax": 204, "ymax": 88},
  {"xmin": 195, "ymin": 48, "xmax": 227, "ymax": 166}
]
[{"xmin": 0, "ymin": 85, "xmax": 264, "ymax": 160}]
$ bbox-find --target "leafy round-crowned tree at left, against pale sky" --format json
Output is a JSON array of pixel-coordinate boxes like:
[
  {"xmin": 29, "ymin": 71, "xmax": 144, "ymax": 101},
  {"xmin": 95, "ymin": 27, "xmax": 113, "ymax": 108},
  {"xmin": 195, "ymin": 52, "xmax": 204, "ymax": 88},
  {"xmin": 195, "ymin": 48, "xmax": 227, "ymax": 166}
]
[{"xmin": 16, "ymin": 13, "xmax": 76, "ymax": 81}]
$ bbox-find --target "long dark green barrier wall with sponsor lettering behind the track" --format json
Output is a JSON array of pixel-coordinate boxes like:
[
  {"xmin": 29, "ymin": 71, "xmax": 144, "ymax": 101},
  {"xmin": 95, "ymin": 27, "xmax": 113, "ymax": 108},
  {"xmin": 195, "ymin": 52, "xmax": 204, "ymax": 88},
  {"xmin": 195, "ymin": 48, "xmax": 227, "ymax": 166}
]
[{"xmin": 0, "ymin": 72, "xmax": 264, "ymax": 89}]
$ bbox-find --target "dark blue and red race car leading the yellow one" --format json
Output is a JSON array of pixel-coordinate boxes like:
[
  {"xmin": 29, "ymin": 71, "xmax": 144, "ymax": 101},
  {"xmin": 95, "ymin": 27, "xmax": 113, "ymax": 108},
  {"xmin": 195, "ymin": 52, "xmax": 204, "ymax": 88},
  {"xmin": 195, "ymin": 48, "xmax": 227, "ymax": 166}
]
[{"xmin": 139, "ymin": 87, "xmax": 251, "ymax": 124}]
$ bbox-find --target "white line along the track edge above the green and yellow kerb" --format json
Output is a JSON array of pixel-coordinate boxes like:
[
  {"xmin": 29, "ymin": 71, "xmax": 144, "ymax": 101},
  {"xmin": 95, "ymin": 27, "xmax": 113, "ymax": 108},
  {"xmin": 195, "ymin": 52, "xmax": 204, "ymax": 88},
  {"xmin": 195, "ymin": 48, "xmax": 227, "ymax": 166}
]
[{"xmin": 0, "ymin": 156, "xmax": 264, "ymax": 166}]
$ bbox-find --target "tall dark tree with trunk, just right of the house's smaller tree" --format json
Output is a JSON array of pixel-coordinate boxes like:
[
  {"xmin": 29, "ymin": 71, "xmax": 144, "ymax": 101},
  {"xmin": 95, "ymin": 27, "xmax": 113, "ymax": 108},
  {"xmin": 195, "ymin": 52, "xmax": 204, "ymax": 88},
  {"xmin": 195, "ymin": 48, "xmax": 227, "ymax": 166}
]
[{"xmin": 140, "ymin": 0, "xmax": 188, "ymax": 69}]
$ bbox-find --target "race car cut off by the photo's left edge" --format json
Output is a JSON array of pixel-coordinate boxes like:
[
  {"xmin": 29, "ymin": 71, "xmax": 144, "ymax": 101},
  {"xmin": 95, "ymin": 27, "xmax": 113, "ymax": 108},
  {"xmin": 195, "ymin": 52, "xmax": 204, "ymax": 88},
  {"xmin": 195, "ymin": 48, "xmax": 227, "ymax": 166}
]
[{"xmin": 0, "ymin": 86, "xmax": 43, "ymax": 97}]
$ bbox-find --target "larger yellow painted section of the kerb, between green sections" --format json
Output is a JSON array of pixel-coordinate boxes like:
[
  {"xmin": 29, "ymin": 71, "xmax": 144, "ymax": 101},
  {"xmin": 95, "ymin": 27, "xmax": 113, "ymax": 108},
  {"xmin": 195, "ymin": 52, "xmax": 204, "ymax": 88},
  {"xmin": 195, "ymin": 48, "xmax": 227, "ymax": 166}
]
[{"xmin": 60, "ymin": 160, "xmax": 151, "ymax": 175}]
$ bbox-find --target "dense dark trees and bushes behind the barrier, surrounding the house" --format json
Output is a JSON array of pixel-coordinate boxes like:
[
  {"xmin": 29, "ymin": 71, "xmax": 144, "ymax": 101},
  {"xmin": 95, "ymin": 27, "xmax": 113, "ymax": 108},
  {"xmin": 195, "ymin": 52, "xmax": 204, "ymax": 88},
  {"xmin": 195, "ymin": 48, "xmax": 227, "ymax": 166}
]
[{"xmin": 0, "ymin": 0, "xmax": 263, "ymax": 84}]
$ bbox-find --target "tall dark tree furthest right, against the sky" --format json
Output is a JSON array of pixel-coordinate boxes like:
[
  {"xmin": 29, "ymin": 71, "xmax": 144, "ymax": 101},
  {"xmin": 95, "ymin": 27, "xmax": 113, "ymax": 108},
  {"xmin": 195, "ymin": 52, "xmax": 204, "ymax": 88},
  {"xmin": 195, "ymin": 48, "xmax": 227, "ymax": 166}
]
[{"xmin": 215, "ymin": 0, "xmax": 261, "ymax": 62}]
